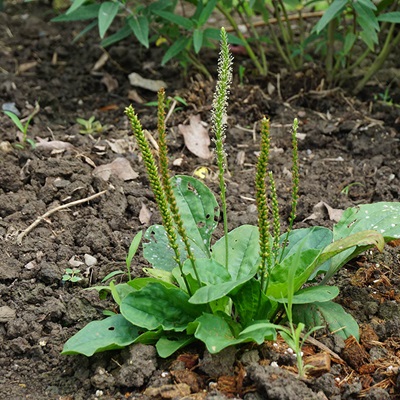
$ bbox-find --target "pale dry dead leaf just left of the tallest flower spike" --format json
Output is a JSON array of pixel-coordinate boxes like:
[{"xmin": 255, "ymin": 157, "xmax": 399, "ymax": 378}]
[{"xmin": 178, "ymin": 115, "xmax": 213, "ymax": 159}]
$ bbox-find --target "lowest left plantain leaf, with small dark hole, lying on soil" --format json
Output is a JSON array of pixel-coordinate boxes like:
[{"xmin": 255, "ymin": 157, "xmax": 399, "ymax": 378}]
[{"xmin": 61, "ymin": 314, "xmax": 140, "ymax": 357}]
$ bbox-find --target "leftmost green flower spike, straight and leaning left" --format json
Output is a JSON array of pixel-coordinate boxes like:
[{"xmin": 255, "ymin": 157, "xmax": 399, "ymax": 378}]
[{"xmin": 125, "ymin": 106, "xmax": 191, "ymax": 295}]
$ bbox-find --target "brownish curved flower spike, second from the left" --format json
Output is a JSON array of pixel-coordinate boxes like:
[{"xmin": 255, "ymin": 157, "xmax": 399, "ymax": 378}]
[{"xmin": 157, "ymin": 89, "xmax": 201, "ymax": 286}]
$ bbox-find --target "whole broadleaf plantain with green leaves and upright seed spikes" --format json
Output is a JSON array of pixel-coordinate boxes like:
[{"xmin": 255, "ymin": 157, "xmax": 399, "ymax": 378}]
[{"xmin": 63, "ymin": 28, "xmax": 400, "ymax": 375}]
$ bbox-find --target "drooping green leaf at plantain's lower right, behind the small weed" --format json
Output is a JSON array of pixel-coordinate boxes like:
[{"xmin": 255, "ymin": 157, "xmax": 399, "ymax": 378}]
[{"xmin": 293, "ymin": 301, "xmax": 359, "ymax": 340}]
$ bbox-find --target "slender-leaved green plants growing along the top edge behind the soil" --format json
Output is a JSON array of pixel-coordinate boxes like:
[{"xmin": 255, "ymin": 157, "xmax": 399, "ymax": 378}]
[{"xmin": 54, "ymin": 0, "xmax": 400, "ymax": 91}]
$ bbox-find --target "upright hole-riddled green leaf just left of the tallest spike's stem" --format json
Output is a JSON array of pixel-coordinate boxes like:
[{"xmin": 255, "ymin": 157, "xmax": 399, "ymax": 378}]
[{"xmin": 171, "ymin": 175, "xmax": 219, "ymax": 258}]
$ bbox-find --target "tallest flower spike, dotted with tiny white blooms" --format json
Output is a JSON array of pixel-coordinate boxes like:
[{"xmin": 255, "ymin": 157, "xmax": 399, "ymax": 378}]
[{"xmin": 211, "ymin": 28, "xmax": 233, "ymax": 267}]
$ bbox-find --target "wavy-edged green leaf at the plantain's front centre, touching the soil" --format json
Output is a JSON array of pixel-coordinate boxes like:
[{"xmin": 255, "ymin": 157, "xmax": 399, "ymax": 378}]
[{"xmin": 194, "ymin": 314, "xmax": 276, "ymax": 354}]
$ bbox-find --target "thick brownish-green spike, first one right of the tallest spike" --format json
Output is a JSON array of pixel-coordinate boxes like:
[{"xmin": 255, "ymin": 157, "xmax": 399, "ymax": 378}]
[{"xmin": 255, "ymin": 117, "xmax": 271, "ymax": 292}]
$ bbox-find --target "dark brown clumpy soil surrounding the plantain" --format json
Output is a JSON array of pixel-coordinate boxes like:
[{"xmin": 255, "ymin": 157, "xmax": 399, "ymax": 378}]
[{"xmin": 0, "ymin": 3, "xmax": 400, "ymax": 400}]
